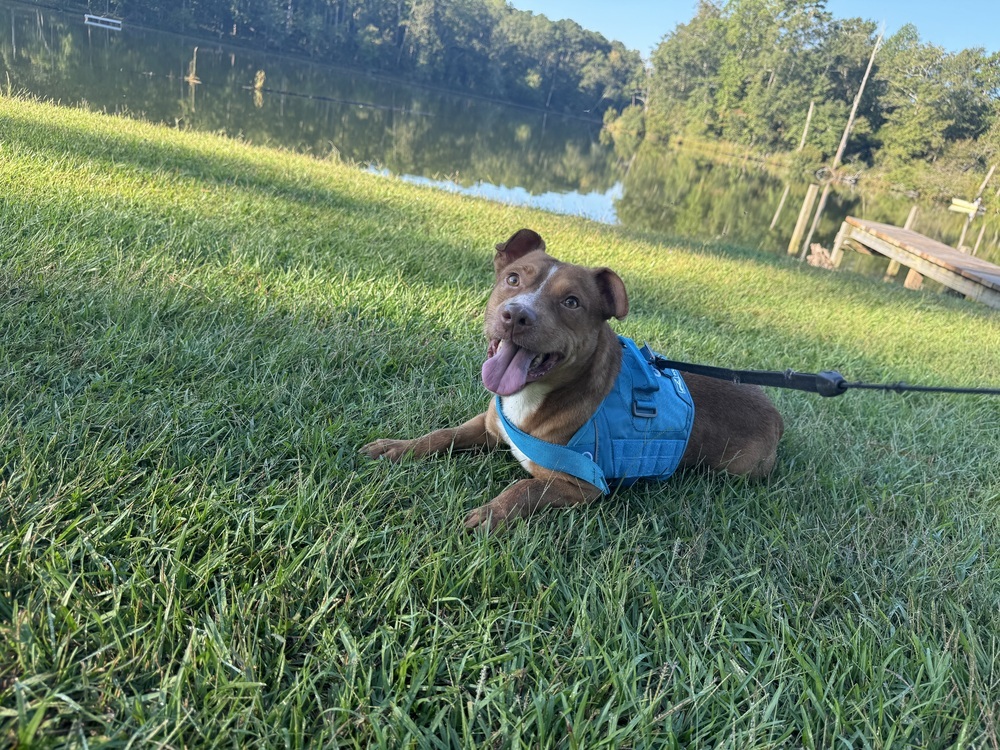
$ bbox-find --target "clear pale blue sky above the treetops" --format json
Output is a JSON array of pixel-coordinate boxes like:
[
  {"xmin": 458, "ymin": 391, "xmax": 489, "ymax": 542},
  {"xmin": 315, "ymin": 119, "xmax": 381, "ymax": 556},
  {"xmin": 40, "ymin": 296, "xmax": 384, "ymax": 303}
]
[{"xmin": 511, "ymin": 0, "xmax": 1000, "ymax": 59}]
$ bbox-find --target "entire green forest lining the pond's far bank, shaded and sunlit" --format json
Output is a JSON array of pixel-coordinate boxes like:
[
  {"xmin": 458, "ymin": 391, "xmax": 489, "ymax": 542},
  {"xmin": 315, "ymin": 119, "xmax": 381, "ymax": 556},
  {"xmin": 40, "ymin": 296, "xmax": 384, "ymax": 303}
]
[{"xmin": 48, "ymin": 0, "xmax": 1000, "ymax": 195}]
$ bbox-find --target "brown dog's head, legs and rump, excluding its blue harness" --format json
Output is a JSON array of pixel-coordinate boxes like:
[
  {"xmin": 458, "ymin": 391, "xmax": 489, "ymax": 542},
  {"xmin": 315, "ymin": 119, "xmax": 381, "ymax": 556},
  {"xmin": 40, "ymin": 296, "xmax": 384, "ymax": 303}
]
[{"xmin": 362, "ymin": 229, "xmax": 783, "ymax": 529}]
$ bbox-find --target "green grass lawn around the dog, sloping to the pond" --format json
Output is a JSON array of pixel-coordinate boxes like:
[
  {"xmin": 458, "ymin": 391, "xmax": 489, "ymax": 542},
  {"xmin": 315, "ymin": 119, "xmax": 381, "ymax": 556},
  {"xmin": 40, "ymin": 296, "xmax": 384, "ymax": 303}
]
[{"xmin": 0, "ymin": 97, "xmax": 1000, "ymax": 748}]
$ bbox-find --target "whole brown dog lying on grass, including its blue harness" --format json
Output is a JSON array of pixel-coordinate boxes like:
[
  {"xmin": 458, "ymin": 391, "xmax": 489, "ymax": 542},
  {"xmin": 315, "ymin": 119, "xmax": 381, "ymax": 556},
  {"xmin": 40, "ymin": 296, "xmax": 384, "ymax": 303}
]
[{"xmin": 361, "ymin": 229, "xmax": 784, "ymax": 531}]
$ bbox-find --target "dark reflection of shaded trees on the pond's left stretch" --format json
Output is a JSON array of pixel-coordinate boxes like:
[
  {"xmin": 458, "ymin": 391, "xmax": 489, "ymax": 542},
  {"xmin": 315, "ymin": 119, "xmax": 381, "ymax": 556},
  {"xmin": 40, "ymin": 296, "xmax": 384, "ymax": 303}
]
[{"xmin": 0, "ymin": 0, "xmax": 621, "ymax": 195}]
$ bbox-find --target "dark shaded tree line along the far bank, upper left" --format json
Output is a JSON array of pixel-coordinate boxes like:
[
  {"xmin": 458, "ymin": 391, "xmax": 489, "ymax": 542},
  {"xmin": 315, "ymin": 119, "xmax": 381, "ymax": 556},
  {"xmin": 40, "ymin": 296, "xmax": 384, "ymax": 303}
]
[{"xmin": 62, "ymin": 0, "xmax": 644, "ymax": 119}]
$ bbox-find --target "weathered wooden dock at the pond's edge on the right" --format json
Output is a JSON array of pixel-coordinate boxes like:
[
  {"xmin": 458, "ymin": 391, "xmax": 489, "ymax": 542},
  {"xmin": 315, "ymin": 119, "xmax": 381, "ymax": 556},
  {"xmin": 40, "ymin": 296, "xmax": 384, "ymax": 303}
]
[{"xmin": 831, "ymin": 216, "xmax": 1000, "ymax": 309}]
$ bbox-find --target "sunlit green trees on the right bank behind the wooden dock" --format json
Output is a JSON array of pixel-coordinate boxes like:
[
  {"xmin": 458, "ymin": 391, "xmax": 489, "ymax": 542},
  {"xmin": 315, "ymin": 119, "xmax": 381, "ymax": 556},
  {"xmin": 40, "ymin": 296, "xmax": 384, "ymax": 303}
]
[{"xmin": 606, "ymin": 0, "xmax": 1000, "ymax": 194}]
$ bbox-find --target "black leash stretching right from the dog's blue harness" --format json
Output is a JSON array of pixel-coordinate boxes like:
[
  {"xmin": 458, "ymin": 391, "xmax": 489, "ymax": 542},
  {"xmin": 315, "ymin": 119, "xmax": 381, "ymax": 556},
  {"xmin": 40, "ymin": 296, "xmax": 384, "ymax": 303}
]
[{"xmin": 652, "ymin": 354, "xmax": 1000, "ymax": 396}]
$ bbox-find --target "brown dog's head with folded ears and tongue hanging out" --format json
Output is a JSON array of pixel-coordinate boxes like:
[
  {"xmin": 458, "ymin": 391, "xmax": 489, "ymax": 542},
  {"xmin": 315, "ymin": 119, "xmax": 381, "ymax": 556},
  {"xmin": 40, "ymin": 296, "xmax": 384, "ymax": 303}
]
[{"xmin": 483, "ymin": 229, "xmax": 628, "ymax": 396}]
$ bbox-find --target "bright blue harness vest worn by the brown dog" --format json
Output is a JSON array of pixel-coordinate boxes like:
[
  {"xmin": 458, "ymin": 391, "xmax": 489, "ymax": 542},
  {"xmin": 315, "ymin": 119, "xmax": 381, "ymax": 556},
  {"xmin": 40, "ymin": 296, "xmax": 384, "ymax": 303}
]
[{"xmin": 496, "ymin": 336, "xmax": 694, "ymax": 494}]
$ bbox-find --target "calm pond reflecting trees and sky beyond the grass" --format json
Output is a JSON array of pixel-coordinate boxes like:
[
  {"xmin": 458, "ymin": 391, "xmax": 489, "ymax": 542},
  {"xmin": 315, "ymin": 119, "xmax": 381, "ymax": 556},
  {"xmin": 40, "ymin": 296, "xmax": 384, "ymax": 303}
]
[{"xmin": 0, "ymin": 0, "xmax": 1000, "ymax": 274}]
